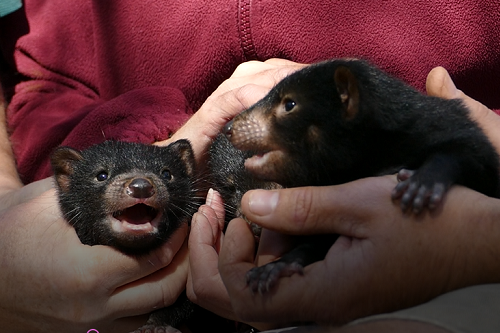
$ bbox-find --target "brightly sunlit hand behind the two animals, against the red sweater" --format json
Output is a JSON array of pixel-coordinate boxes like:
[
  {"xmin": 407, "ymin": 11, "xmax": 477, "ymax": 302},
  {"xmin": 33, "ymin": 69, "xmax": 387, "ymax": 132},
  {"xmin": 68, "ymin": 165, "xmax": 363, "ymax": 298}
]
[{"xmin": 157, "ymin": 59, "xmax": 305, "ymax": 162}]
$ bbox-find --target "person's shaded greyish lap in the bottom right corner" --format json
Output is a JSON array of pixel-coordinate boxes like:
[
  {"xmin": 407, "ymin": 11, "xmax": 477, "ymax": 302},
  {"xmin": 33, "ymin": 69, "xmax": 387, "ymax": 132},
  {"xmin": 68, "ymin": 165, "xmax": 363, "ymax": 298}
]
[{"xmin": 260, "ymin": 284, "xmax": 500, "ymax": 333}]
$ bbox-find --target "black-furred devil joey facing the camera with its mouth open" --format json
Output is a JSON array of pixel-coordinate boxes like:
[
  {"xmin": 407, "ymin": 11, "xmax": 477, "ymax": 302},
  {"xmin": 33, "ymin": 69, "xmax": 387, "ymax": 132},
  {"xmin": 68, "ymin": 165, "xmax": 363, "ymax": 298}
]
[{"xmin": 51, "ymin": 140, "xmax": 199, "ymax": 329}]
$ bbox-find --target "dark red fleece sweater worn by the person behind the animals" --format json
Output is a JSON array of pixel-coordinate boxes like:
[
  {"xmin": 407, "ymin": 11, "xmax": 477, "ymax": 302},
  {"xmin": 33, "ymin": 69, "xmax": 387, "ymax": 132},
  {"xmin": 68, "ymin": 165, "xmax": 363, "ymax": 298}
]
[{"xmin": 0, "ymin": 0, "xmax": 500, "ymax": 183}]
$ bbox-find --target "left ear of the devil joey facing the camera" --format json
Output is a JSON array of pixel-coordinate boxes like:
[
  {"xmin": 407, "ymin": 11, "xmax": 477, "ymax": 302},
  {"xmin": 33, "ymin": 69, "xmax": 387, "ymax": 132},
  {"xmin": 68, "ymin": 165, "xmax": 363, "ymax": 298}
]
[{"xmin": 50, "ymin": 147, "xmax": 83, "ymax": 192}]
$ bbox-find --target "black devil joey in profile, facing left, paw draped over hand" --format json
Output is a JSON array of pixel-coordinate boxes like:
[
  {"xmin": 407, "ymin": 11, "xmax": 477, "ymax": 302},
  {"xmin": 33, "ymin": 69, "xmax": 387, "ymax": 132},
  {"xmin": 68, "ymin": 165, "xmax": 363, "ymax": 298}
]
[{"xmin": 213, "ymin": 59, "xmax": 500, "ymax": 292}]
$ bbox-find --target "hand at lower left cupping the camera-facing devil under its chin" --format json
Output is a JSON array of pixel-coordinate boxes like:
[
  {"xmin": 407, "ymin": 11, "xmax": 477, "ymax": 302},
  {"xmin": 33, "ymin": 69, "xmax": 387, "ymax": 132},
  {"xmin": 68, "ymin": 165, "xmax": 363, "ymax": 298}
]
[{"xmin": 0, "ymin": 179, "xmax": 188, "ymax": 333}]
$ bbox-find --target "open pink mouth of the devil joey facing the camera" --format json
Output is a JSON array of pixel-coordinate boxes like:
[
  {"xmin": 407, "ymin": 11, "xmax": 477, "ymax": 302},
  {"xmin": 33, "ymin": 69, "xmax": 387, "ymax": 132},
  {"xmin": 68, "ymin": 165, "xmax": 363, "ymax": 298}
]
[{"xmin": 112, "ymin": 203, "xmax": 161, "ymax": 234}]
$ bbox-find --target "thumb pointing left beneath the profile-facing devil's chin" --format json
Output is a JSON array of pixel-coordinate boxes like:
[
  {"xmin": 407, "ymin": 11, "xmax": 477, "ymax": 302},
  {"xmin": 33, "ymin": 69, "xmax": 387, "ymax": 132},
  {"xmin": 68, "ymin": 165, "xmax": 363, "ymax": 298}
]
[{"xmin": 241, "ymin": 176, "xmax": 397, "ymax": 238}]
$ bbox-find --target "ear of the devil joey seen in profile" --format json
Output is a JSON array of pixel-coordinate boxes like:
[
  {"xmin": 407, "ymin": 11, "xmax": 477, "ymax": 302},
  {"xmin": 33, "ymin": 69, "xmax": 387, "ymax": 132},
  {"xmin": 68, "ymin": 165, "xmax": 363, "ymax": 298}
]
[{"xmin": 334, "ymin": 66, "xmax": 359, "ymax": 120}]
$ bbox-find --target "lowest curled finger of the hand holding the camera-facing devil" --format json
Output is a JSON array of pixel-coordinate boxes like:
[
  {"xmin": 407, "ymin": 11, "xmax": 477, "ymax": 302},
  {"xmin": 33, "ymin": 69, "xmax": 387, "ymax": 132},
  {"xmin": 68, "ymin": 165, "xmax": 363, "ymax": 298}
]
[{"xmin": 107, "ymin": 236, "xmax": 189, "ymax": 317}]
